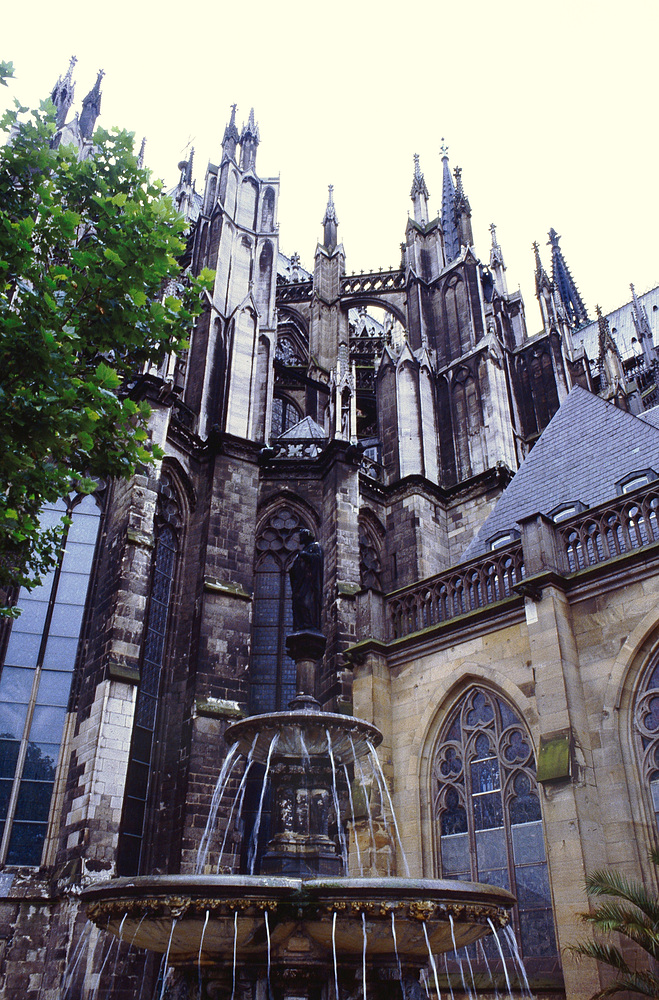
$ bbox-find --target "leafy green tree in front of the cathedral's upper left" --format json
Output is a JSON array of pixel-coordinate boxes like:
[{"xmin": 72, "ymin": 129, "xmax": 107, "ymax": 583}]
[{"xmin": 0, "ymin": 63, "xmax": 209, "ymax": 589}]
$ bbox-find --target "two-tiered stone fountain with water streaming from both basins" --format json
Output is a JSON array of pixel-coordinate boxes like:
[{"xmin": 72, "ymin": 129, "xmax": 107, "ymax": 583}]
[{"xmin": 83, "ymin": 540, "xmax": 514, "ymax": 1000}]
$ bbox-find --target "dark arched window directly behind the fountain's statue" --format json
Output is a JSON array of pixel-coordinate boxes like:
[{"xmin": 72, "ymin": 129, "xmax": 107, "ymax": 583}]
[{"xmin": 250, "ymin": 506, "xmax": 309, "ymax": 713}]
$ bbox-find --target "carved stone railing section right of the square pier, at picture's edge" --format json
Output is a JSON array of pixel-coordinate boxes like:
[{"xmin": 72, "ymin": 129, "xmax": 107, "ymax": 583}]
[{"xmin": 556, "ymin": 482, "xmax": 659, "ymax": 573}]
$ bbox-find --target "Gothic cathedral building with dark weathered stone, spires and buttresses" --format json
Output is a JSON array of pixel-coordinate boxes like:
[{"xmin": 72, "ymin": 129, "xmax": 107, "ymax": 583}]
[{"xmin": 0, "ymin": 66, "xmax": 659, "ymax": 1000}]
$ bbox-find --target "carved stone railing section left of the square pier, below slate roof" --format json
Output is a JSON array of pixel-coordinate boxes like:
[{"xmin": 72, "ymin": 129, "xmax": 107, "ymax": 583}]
[{"xmin": 387, "ymin": 542, "xmax": 524, "ymax": 639}]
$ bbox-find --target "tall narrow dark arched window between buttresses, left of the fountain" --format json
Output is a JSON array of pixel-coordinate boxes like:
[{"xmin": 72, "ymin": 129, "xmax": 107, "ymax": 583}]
[{"xmin": 117, "ymin": 472, "xmax": 182, "ymax": 875}]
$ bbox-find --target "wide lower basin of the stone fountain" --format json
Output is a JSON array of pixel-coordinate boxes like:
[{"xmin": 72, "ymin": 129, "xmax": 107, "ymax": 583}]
[{"xmin": 82, "ymin": 875, "xmax": 515, "ymax": 965}]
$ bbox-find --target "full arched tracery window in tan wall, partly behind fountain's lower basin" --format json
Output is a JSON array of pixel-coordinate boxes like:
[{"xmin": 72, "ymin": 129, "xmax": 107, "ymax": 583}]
[{"xmin": 432, "ymin": 687, "xmax": 557, "ymax": 969}]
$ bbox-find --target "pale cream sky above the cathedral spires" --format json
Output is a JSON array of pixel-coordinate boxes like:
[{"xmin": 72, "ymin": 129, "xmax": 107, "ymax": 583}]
[{"xmin": 0, "ymin": 0, "xmax": 659, "ymax": 333}]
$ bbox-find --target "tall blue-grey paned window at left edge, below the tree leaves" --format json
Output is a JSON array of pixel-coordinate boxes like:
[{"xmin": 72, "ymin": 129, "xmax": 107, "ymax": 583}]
[{"xmin": 0, "ymin": 495, "xmax": 100, "ymax": 865}]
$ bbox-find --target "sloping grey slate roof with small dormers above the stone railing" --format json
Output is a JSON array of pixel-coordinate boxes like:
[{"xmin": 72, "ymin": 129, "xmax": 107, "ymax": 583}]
[{"xmin": 462, "ymin": 386, "xmax": 659, "ymax": 560}]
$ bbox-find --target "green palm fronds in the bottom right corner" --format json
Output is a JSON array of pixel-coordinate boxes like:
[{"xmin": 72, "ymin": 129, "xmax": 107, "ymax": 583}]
[{"xmin": 572, "ymin": 848, "xmax": 659, "ymax": 1000}]
